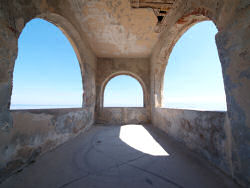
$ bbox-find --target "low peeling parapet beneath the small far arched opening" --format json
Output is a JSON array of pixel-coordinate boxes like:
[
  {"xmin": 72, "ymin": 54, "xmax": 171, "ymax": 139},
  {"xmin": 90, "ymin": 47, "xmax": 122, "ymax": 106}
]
[{"xmin": 96, "ymin": 107, "xmax": 150, "ymax": 125}]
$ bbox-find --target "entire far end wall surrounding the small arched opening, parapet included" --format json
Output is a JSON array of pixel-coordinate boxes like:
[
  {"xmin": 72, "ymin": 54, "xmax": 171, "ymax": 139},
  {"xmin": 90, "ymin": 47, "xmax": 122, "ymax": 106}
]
[{"xmin": 96, "ymin": 58, "xmax": 150, "ymax": 124}]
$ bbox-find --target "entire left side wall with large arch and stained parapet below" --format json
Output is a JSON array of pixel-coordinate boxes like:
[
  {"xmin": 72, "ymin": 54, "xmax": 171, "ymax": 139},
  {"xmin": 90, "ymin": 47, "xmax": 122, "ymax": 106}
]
[{"xmin": 0, "ymin": 0, "xmax": 96, "ymax": 181}]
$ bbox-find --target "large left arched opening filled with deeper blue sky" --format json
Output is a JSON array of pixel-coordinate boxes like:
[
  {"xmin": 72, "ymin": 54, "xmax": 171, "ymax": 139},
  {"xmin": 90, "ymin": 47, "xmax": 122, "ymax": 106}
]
[{"xmin": 10, "ymin": 18, "xmax": 83, "ymax": 109}]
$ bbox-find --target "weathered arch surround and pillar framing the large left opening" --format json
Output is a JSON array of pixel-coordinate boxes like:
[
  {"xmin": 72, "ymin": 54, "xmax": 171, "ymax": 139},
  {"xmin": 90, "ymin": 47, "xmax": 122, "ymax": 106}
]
[{"xmin": 0, "ymin": 12, "xmax": 95, "ymax": 126}]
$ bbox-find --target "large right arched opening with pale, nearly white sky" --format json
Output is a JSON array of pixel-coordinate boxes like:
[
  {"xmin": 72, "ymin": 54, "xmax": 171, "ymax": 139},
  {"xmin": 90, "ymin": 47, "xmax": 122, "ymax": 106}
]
[{"xmin": 163, "ymin": 21, "xmax": 227, "ymax": 111}]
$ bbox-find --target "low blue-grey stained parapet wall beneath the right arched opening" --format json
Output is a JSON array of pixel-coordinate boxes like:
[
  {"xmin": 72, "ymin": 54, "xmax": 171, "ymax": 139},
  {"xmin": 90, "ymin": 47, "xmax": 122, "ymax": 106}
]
[{"xmin": 152, "ymin": 108, "xmax": 231, "ymax": 172}]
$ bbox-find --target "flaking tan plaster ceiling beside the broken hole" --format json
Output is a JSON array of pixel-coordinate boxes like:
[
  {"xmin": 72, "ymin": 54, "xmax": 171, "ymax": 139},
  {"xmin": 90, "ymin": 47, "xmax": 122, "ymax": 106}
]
[{"xmin": 70, "ymin": 0, "xmax": 158, "ymax": 58}]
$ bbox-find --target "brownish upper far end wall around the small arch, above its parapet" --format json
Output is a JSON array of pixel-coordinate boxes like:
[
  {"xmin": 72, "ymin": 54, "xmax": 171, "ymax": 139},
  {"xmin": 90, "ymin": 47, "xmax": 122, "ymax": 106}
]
[{"xmin": 96, "ymin": 58, "xmax": 150, "ymax": 114}]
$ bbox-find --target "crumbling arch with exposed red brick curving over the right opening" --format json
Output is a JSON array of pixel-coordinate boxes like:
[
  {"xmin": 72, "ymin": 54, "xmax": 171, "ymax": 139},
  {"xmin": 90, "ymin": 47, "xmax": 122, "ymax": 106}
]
[{"xmin": 151, "ymin": 7, "xmax": 224, "ymax": 107}]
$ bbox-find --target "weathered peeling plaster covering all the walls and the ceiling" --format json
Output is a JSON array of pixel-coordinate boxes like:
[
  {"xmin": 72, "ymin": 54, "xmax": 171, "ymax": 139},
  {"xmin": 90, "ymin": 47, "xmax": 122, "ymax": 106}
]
[{"xmin": 0, "ymin": 0, "xmax": 250, "ymax": 186}]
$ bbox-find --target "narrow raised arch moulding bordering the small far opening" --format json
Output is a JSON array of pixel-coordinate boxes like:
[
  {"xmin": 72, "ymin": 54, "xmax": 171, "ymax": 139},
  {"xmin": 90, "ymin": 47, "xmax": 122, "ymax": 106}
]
[{"xmin": 99, "ymin": 71, "xmax": 148, "ymax": 108}]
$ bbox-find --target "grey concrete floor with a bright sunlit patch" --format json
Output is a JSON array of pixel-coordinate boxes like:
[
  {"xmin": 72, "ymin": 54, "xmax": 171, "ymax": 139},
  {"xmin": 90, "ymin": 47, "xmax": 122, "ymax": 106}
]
[{"xmin": 0, "ymin": 125, "xmax": 241, "ymax": 188}]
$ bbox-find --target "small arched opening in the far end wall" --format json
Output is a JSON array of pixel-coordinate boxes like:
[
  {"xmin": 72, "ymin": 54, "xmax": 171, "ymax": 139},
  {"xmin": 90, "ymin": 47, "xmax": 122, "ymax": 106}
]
[{"xmin": 103, "ymin": 75, "xmax": 144, "ymax": 107}]
